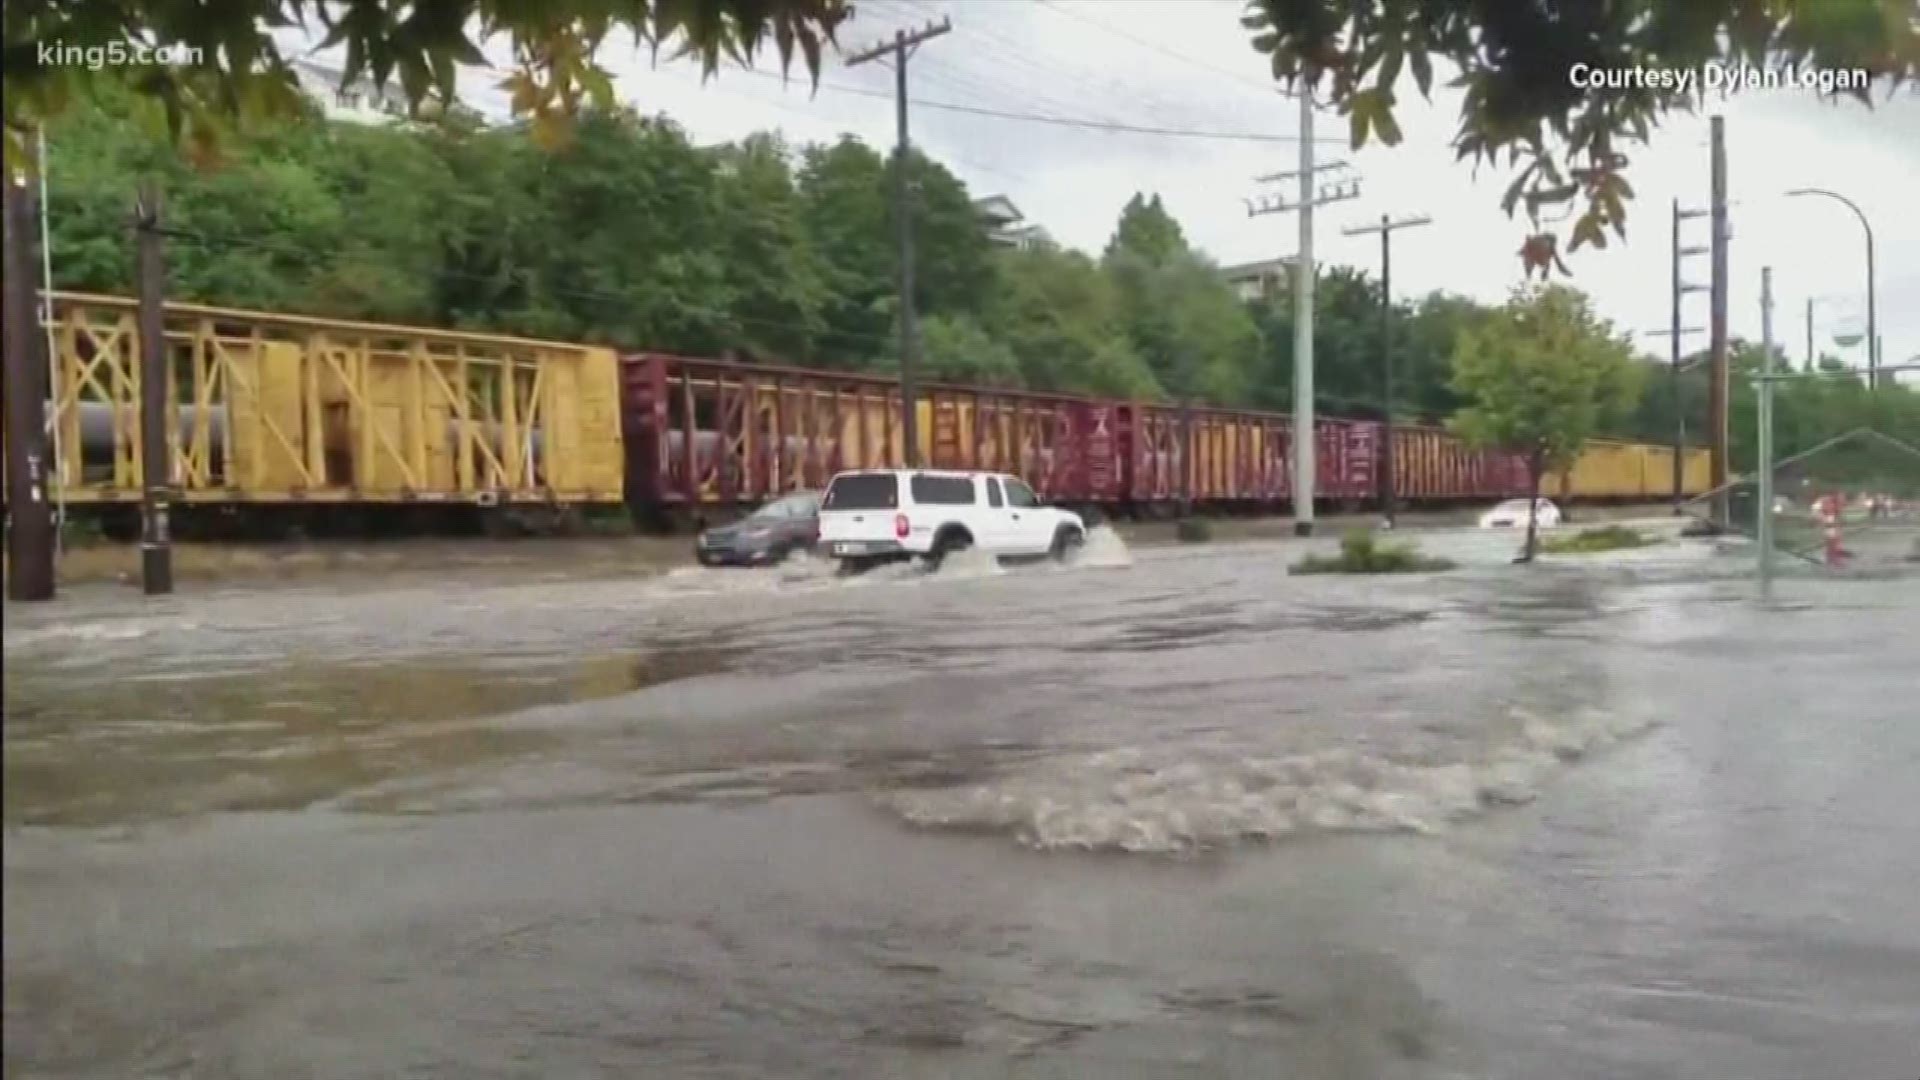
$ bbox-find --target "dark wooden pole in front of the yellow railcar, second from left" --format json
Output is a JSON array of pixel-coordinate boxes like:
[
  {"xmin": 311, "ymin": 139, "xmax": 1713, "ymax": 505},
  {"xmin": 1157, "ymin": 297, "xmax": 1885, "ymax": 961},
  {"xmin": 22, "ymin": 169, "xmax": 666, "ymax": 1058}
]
[{"xmin": 134, "ymin": 183, "xmax": 173, "ymax": 596}]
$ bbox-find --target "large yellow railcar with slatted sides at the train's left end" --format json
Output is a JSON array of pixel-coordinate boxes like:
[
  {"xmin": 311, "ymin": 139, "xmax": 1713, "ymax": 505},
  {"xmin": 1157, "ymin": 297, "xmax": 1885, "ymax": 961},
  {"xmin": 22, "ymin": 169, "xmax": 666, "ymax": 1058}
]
[{"xmin": 31, "ymin": 294, "xmax": 622, "ymax": 503}]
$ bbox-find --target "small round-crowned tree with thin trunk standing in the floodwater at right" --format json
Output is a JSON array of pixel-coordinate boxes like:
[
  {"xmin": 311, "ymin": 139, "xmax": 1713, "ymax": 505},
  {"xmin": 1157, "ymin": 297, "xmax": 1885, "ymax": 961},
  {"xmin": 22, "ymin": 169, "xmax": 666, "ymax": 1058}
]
[{"xmin": 1452, "ymin": 284, "xmax": 1638, "ymax": 561}]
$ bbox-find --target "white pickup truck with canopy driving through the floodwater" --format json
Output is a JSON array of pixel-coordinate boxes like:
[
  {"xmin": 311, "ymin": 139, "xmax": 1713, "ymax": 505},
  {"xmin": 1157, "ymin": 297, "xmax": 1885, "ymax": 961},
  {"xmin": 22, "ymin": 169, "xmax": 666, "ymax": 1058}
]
[{"xmin": 820, "ymin": 469, "xmax": 1087, "ymax": 571}]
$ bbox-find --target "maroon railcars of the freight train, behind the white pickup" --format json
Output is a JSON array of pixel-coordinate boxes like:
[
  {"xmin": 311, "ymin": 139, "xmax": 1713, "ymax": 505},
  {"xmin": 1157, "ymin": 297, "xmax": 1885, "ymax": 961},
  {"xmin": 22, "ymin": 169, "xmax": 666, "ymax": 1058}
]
[{"xmin": 622, "ymin": 345, "xmax": 1526, "ymax": 509}]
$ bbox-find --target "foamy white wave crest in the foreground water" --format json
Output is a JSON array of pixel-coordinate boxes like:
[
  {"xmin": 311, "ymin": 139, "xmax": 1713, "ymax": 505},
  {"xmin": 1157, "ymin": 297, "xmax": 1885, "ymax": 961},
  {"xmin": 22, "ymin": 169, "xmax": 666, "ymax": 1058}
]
[{"xmin": 881, "ymin": 713, "xmax": 1651, "ymax": 853}]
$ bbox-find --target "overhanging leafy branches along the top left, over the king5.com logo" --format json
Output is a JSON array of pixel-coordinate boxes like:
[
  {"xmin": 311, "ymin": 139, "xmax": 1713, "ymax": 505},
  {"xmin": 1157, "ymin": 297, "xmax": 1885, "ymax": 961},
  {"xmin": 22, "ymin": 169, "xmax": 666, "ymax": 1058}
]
[{"xmin": 4, "ymin": 0, "xmax": 852, "ymax": 165}]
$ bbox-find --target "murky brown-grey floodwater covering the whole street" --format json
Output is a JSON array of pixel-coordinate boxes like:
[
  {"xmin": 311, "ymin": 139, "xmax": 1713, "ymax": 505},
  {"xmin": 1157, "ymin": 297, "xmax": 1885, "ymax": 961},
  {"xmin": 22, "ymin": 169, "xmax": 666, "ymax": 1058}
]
[{"xmin": 4, "ymin": 518, "xmax": 1920, "ymax": 1080}]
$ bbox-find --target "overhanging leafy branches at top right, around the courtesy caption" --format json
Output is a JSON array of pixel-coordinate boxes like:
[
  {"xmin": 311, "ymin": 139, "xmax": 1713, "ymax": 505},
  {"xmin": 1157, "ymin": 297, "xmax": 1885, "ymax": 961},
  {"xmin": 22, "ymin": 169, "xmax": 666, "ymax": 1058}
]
[{"xmin": 1242, "ymin": 0, "xmax": 1920, "ymax": 273}]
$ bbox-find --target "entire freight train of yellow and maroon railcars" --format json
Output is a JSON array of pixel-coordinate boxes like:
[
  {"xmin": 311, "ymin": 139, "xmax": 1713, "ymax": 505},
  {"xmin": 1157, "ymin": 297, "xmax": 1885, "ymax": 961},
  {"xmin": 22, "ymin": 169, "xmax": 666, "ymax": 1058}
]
[{"xmin": 10, "ymin": 294, "xmax": 1709, "ymax": 532}]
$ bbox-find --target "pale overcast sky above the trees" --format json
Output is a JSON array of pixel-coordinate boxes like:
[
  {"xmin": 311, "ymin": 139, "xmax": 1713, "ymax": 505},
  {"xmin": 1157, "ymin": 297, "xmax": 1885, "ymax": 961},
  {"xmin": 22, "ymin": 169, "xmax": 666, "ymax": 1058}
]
[{"xmin": 370, "ymin": 0, "xmax": 1920, "ymax": 379}]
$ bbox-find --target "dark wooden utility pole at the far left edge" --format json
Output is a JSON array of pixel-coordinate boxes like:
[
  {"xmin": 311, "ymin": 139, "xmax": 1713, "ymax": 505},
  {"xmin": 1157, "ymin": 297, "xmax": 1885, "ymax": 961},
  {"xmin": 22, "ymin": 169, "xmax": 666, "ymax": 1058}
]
[{"xmin": 0, "ymin": 165, "xmax": 54, "ymax": 601}]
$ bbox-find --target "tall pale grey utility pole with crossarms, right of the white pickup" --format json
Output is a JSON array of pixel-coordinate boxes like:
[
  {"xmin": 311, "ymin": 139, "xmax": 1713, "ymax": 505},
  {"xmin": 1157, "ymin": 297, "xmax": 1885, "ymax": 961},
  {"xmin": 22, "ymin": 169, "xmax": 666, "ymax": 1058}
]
[{"xmin": 1246, "ymin": 92, "xmax": 1359, "ymax": 536}]
